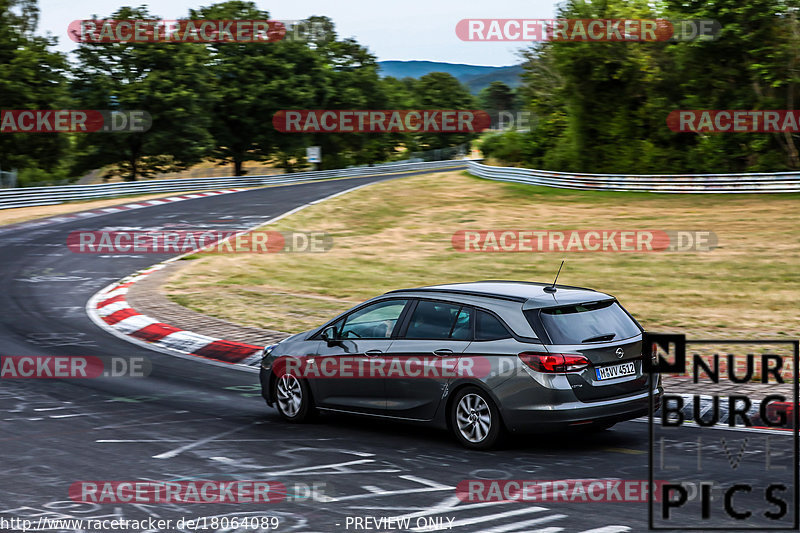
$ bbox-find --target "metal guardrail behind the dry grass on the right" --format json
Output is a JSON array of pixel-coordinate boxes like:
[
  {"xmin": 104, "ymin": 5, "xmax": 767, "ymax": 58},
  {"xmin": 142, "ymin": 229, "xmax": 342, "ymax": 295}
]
[{"xmin": 468, "ymin": 161, "xmax": 800, "ymax": 193}]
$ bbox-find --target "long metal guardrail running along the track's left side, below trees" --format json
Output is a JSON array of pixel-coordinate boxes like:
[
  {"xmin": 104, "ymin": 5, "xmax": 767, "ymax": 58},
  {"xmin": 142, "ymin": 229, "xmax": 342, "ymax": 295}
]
[{"xmin": 0, "ymin": 160, "xmax": 466, "ymax": 209}]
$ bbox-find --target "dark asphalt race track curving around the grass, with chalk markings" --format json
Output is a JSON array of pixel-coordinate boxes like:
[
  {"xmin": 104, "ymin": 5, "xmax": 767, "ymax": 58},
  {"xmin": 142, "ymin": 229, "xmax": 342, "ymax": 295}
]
[{"xmin": 0, "ymin": 168, "xmax": 795, "ymax": 533}]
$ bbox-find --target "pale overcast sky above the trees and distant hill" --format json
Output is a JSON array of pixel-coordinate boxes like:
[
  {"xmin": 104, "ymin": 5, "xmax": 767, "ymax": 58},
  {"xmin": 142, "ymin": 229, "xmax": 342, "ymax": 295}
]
[{"xmin": 39, "ymin": 0, "xmax": 556, "ymax": 66}]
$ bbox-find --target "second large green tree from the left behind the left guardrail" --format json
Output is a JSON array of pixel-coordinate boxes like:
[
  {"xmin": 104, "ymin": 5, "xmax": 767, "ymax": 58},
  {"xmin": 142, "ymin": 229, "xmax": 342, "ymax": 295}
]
[{"xmin": 72, "ymin": 7, "xmax": 215, "ymax": 181}]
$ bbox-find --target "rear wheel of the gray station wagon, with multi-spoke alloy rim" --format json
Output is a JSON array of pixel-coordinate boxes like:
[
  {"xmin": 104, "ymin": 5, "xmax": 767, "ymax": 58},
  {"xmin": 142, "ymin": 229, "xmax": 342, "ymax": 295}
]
[{"xmin": 449, "ymin": 386, "xmax": 503, "ymax": 450}]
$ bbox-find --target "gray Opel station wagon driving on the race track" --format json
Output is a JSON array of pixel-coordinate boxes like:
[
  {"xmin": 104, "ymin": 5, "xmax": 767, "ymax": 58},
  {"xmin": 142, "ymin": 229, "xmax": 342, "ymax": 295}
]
[{"xmin": 260, "ymin": 281, "xmax": 663, "ymax": 449}]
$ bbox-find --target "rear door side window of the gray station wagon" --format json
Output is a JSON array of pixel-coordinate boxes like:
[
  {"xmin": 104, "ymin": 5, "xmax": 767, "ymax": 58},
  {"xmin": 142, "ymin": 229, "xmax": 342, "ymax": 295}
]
[{"xmin": 405, "ymin": 300, "xmax": 472, "ymax": 339}]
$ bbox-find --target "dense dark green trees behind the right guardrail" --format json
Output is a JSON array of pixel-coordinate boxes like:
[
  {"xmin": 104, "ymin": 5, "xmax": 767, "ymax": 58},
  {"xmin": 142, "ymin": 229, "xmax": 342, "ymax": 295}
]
[{"xmin": 482, "ymin": 0, "xmax": 800, "ymax": 174}]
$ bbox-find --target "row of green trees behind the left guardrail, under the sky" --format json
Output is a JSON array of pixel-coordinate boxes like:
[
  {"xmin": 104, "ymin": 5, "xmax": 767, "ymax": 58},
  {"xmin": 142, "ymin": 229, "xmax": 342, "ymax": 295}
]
[{"xmin": 0, "ymin": 0, "xmax": 478, "ymax": 185}]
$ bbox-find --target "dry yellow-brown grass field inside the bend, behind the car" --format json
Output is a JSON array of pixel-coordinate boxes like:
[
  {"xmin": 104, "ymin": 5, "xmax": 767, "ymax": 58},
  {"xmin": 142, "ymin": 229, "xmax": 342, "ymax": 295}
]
[{"xmin": 167, "ymin": 172, "xmax": 800, "ymax": 338}]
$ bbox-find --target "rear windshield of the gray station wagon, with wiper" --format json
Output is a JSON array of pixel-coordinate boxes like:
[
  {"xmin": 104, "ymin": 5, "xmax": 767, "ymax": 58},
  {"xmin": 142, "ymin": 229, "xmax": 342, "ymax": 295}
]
[{"xmin": 525, "ymin": 300, "xmax": 641, "ymax": 344}]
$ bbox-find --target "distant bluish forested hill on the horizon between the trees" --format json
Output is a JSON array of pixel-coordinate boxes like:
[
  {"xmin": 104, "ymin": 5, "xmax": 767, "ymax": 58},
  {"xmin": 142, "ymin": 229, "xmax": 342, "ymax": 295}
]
[{"xmin": 378, "ymin": 61, "xmax": 523, "ymax": 93}]
